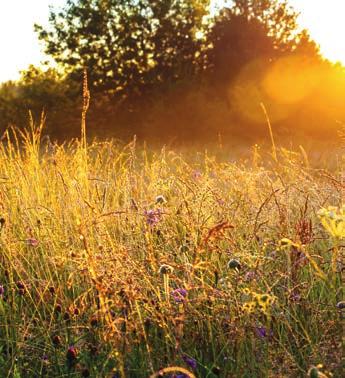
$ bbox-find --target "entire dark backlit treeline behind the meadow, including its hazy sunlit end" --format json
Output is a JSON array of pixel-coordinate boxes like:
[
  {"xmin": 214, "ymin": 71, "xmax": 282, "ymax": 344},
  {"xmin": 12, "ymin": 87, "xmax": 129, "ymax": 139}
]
[{"xmin": 0, "ymin": 0, "xmax": 345, "ymax": 140}]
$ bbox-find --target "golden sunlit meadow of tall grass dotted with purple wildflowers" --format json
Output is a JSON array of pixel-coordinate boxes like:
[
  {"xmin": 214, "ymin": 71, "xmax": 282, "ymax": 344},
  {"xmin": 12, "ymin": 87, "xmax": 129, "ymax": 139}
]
[{"xmin": 0, "ymin": 122, "xmax": 345, "ymax": 378}]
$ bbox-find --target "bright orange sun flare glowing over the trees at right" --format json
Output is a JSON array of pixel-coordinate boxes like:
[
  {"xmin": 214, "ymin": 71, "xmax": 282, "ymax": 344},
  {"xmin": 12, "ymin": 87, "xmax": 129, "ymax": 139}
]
[{"xmin": 228, "ymin": 55, "xmax": 345, "ymax": 124}]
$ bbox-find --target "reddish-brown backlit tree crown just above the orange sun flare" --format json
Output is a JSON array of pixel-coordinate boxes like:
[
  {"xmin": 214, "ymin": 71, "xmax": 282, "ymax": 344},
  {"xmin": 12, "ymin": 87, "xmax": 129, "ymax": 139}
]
[{"xmin": 208, "ymin": 0, "xmax": 318, "ymax": 86}]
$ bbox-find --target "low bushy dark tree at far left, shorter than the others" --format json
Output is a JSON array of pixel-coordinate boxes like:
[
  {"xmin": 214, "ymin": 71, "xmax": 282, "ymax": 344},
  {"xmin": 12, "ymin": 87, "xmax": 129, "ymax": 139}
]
[{"xmin": 0, "ymin": 65, "xmax": 80, "ymax": 137}]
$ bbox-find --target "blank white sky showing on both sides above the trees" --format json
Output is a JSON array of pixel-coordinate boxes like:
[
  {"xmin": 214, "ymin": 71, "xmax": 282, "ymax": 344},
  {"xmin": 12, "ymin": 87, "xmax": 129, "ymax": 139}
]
[{"xmin": 0, "ymin": 0, "xmax": 345, "ymax": 82}]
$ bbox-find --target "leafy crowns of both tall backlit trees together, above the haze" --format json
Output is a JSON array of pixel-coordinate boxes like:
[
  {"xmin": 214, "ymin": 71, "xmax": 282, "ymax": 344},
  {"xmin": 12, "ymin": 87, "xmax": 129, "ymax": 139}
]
[{"xmin": 36, "ymin": 0, "xmax": 320, "ymax": 102}]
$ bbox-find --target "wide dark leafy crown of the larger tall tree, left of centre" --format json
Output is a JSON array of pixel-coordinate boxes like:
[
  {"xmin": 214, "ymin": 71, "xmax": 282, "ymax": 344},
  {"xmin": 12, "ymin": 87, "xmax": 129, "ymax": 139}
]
[{"xmin": 36, "ymin": 0, "xmax": 209, "ymax": 102}]
